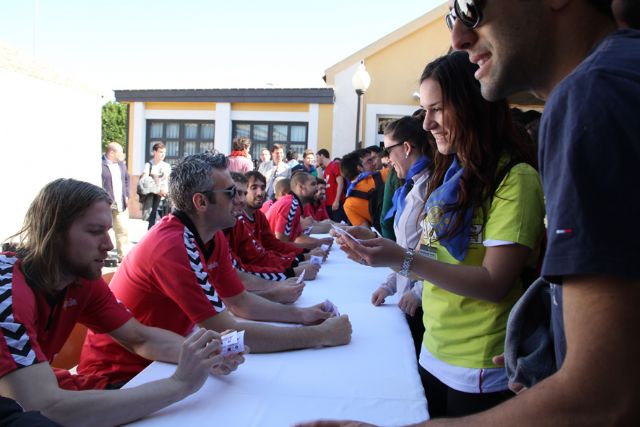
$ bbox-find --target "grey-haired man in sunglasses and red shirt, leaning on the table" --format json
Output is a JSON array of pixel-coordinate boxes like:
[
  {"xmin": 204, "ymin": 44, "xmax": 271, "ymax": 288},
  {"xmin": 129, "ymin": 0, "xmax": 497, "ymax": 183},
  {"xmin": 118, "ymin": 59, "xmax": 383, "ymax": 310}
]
[{"xmin": 78, "ymin": 153, "xmax": 351, "ymax": 384}]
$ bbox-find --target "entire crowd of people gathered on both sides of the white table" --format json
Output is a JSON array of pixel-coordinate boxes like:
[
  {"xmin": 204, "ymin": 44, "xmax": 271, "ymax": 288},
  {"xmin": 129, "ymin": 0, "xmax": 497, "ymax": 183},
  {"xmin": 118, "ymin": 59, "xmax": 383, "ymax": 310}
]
[{"xmin": 0, "ymin": 0, "xmax": 640, "ymax": 427}]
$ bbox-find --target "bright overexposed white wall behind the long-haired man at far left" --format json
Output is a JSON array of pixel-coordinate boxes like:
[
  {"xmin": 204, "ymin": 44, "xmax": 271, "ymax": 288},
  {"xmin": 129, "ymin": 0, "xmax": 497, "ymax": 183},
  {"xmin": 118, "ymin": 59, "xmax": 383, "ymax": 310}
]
[{"xmin": 0, "ymin": 69, "xmax": 104, "ymax": 241}]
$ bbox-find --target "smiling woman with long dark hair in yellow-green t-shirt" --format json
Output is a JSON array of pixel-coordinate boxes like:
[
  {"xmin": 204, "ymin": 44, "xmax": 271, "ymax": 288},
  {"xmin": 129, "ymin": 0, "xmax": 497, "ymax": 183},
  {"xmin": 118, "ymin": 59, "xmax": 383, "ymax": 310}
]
[{"xmin": 339, "ymin": 52, "xmax": 544, "ymax": 417}]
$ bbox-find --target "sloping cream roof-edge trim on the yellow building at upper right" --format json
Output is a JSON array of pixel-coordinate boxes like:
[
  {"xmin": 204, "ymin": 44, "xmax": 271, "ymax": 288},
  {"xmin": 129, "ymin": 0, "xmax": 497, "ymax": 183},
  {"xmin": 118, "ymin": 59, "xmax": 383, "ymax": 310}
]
[{"xmin": 325, "ymin": 2, "xmax": 449, "ymax": 86}]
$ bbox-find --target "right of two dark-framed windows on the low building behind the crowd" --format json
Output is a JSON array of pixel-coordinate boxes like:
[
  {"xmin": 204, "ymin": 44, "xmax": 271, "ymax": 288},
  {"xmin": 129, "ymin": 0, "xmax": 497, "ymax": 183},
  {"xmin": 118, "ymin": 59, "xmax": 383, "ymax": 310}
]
[{"xmin": 233, "ymin": 121, "xmax": 308, "ymax": 167}]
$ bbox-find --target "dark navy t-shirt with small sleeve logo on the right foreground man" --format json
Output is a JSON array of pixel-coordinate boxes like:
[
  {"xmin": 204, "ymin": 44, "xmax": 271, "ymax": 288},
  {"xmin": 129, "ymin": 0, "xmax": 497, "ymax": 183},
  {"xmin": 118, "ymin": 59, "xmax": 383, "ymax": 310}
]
[{"xmin": 539, "ymin": 30, "xmax": 640, "ymax": 367}]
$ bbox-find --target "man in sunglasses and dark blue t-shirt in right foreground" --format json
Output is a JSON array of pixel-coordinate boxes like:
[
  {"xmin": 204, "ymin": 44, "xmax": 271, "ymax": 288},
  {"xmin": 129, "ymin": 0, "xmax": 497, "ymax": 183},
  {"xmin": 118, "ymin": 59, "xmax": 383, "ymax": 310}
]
[{"xmin": 298, "ymin": 0, "xmax": 640, "ymax": 427}]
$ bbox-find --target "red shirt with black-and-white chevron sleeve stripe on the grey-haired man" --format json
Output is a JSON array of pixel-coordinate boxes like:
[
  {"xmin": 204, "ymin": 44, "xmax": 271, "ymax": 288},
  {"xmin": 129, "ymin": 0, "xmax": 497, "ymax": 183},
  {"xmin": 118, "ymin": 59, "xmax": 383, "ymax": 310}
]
[{"xmin": 78, "ymin": 213, "xmax": 244, "ymax": 384}]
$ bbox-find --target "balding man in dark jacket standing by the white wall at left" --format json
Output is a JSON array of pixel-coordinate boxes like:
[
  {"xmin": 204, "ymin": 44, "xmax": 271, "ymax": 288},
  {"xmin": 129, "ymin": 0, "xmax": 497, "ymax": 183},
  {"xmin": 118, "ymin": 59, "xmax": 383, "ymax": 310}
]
[{"xmin": 102, "ymin": 142, "xmax": 129, "ymax": 262}]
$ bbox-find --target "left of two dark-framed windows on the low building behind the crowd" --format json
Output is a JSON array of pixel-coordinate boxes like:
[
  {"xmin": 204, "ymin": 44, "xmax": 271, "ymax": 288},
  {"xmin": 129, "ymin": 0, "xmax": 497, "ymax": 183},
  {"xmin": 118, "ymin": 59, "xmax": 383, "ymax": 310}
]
[{"xmin": 145, "ymin": 120, "xmax": 215, "ymax": 163}]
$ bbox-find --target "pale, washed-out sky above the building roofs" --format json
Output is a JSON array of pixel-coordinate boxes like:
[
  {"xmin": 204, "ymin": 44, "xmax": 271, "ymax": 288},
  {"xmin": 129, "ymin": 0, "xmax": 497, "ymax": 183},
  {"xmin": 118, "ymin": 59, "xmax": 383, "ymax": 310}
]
[{"xmin": 0, "ymin": 0, "xmax": 443, "ymax": 89}]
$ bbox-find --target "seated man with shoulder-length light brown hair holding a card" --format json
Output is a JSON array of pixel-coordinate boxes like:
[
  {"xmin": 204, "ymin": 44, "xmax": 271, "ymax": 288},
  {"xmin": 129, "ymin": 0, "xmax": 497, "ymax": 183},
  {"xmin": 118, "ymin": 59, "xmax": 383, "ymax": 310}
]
[{"xmin": 0, "ymin": 179, "xmax": 243, "ymax": 426}]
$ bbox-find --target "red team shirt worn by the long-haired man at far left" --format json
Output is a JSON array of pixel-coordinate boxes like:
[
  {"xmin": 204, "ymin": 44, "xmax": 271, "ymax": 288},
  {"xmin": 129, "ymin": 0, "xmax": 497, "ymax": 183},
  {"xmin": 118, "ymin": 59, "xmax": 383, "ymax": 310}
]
[{"xmin": 0, "ymin": 252, "xmax": 131, "ymax": 390}]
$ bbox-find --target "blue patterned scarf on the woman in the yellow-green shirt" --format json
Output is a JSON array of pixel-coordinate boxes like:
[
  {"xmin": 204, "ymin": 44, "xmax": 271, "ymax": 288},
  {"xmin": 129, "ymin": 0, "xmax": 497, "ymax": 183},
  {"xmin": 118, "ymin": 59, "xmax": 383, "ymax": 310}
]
[{"xmin": 425, "ymin": 157, "xmax": 473, "ymax": 261}]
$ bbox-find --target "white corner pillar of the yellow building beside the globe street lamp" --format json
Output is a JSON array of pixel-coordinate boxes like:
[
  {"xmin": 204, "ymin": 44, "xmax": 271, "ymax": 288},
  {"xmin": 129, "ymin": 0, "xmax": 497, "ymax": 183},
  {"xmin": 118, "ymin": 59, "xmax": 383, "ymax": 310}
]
[{"xmin": 331, "ymin": 62, "xmax": 360, "ymax": 157}]
